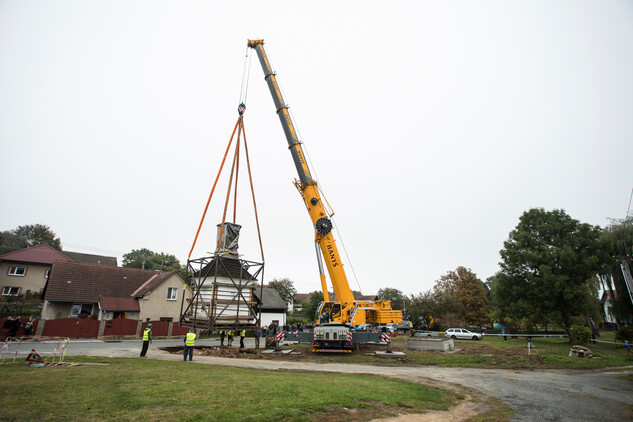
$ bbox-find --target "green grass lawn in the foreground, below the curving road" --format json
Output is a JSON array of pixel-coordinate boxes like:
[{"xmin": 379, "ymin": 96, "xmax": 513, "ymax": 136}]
[{"xmin": 0, "ymin": 357, "xmax": 461, "ymax": 422}]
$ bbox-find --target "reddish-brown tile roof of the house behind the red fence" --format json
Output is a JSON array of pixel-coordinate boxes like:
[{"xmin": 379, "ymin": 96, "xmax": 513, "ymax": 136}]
[{"xmin": 44, "ymin": 261, "xmax": 173, "ymax": 303}]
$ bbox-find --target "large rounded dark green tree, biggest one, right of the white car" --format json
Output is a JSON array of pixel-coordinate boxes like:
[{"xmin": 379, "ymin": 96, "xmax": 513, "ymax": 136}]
[{"xmin": 493, "ymin": 208, "xmax": 605, "ymax": 335}]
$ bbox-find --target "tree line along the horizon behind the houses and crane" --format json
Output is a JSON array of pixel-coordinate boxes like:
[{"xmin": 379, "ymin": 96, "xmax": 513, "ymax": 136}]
[{"xmin": 0, "ymin": 208, "xmax": 633, "ymax": 334}]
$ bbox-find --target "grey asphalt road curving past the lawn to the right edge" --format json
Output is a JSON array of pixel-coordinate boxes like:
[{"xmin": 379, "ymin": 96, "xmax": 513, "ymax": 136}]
[{"xmin": 6, "ymin": 338, "xmax": 633, "ymax": 421}]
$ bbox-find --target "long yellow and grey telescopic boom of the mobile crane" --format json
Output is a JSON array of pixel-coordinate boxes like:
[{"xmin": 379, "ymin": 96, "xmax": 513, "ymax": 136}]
[{"xmin": 248, "ymin": 40, "xmax": 354, "ymax": 304}]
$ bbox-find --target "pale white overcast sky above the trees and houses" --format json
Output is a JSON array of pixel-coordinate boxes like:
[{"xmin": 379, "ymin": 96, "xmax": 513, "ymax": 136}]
[{"xmin": 0, "ymin": 0, "xmax": 633, "ymax": 294}]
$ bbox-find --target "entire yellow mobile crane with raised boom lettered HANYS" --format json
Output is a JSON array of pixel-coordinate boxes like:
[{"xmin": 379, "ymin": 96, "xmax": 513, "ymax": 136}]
[{"xmin": 248, "ymin": 40, "xmax": 402, "ymax": 350}]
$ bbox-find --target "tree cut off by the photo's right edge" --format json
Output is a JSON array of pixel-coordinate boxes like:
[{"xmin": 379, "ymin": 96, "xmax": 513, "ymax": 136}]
[{"xmin": 601, "ymin": 217, "xmax": 633, "ymax": 321}]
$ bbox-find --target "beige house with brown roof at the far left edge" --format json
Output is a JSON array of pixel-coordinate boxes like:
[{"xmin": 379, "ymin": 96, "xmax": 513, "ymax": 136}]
[{"xmin": 0, "ymin": 244, "xmax": 71, "ymax": 296}]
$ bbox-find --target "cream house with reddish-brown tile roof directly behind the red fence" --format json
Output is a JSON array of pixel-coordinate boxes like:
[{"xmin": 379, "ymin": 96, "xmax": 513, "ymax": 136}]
[{"xmin": 42, "ymin": 260, "xmax": 184, "ymax": 321}]
